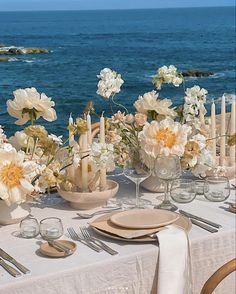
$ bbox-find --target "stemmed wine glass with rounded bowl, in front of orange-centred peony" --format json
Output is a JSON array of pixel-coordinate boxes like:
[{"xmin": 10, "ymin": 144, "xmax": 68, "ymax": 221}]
[{"xmin": 155, "ymin": 154, "xmax": 181, "ymax": 211}]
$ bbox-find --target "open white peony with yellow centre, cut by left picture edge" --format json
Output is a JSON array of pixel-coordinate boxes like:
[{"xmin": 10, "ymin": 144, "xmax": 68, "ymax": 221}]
[{"xmin": 0, "ymin": 149, "xmax": 36, "ymax": 205}]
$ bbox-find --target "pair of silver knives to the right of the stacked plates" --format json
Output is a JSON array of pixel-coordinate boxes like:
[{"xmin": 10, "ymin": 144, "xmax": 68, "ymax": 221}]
[{"xmin": 179, "ymin": 210, "xmax": 222, "ymax": 233}]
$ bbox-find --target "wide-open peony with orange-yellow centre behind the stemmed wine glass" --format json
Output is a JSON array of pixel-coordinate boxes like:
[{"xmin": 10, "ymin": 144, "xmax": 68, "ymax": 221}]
[{"xmin": 139, "ymin": 118, "xmax": 191, "ymax": 165}]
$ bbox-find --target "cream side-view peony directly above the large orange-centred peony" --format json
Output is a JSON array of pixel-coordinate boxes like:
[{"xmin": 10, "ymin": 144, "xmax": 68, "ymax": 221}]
[{"xmin": 134, "ymin": 90, "xmax": 176, "ymax": 117}]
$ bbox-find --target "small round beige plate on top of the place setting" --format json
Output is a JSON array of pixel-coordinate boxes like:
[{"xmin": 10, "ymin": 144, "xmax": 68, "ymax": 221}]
[{"xmin": 110, "ymin": 209, "xmax": 179, "ymax": 229}]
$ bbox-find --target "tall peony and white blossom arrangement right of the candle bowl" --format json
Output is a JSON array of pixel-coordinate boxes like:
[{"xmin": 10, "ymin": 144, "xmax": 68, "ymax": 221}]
[{"xmin": 97, "ymin": 65, "xmax": 214, "ymax": 179}]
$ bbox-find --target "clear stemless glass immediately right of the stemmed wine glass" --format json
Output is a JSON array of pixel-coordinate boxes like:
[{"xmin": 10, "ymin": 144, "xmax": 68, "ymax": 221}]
[{"xmin": 170, "ymin": 179, "xmax": 196, "ymax": 203}]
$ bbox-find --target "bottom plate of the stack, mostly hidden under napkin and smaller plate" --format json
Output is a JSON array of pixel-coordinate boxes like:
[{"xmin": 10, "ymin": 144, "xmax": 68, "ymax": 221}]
[{"xmin": 91, "ymin": 215, "xmax": 192, "ymax": 242}]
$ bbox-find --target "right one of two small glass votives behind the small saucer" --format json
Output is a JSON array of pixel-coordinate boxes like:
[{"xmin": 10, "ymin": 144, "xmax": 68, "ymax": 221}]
[{"xmin": 39, "ymin": 217, "xmax": 63, "ymax": 241}]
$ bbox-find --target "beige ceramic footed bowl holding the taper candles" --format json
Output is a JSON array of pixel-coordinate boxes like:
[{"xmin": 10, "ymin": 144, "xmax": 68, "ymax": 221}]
[{"xmin": 58, "ymin": 180, "xmax": 119, "ymax": 210}]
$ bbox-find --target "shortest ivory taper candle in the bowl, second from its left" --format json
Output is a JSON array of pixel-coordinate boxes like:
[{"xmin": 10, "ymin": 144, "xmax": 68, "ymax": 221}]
[{"xmin": 81, "ymin": 132, "xmax": 88, "ymax": 192}]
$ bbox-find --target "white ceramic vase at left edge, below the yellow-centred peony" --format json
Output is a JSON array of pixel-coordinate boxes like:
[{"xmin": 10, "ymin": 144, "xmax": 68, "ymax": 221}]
[{"xmin": 0, "ymin": 200, "xmax": 30, "ymax": 225}]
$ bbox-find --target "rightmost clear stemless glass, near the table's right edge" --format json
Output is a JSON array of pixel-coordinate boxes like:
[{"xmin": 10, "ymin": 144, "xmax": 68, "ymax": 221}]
[{"xmin": 204, "ymin": 176, "xmax": 230, "ymax": 202}]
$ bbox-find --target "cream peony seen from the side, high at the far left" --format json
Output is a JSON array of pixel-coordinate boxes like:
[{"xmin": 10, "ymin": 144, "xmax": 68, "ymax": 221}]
[{"xmin": 7, "ymin": 88, "xmax": 57, "ymax": 125}]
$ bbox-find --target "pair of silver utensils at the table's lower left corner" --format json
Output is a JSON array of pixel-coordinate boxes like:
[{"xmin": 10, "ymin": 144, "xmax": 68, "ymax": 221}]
[{"xmin": 0, "ymin": 248, "xmax": 30, "ymax": 277}]
